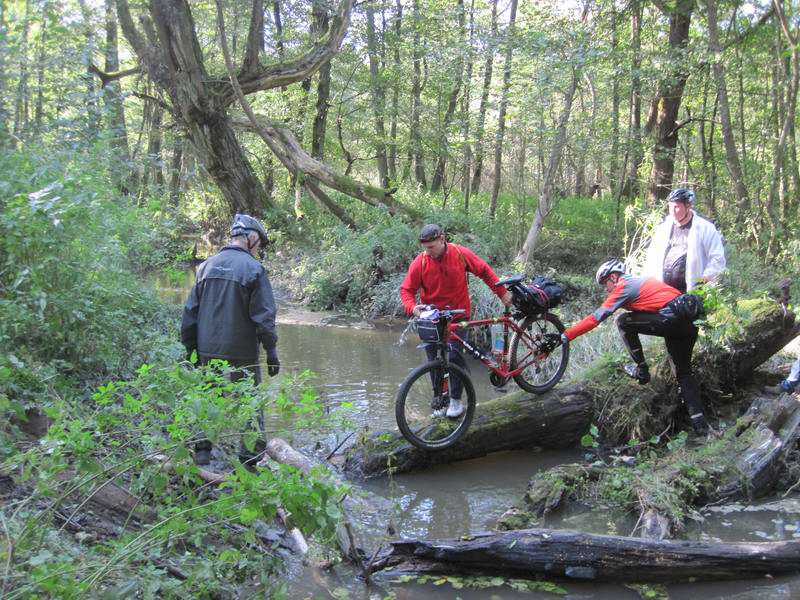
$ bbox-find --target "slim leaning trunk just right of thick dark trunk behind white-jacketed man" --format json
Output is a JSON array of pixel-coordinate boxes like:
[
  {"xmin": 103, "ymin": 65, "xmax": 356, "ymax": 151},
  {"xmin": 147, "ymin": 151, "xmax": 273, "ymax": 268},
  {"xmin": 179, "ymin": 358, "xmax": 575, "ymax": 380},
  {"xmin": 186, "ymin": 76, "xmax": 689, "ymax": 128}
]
[{"xmin": 706, "ymin": 0, "xmax": 750, "ymax": 220}]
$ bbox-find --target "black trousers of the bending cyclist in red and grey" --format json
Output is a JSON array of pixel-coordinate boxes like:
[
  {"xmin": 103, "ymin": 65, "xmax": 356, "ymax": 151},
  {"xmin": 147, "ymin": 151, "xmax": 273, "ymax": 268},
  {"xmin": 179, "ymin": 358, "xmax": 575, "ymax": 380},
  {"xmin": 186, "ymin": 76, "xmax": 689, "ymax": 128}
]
[{"xmin": 617, "ymin": 311, "xmax": 703, "ymax": 415}]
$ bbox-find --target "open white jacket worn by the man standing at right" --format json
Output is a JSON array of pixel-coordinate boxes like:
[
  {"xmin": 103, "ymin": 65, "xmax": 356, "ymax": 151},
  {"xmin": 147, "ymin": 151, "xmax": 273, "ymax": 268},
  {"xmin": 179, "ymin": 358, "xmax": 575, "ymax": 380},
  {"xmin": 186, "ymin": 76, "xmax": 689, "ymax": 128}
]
[{"xmin": 643, "ymin": 210, "xmax": 725, "ymax": 290}]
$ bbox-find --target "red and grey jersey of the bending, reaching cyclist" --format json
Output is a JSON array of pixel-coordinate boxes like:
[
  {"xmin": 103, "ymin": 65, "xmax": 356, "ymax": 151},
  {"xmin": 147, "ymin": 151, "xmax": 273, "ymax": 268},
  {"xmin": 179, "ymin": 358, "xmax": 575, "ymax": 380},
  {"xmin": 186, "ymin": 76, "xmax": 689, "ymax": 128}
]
[{"xmin": 564, "ymin": 275, "xmax": 681, "ymax": 341}]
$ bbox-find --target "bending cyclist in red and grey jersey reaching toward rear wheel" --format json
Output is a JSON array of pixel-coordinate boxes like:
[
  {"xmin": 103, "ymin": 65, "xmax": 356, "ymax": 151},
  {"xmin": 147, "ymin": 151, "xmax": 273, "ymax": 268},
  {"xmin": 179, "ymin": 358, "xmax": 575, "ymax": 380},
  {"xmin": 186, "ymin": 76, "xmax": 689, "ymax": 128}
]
[{"xmin": 561, "ymin": 259, "xmax": 708, "ymax": 434}]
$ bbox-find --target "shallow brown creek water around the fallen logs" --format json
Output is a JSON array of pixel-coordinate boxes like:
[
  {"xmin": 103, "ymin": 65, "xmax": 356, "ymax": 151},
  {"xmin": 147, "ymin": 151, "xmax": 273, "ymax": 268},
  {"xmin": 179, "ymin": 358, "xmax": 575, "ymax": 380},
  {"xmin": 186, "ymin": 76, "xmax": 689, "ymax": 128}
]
[{"xmin": 157, "ymin": 274, "xmax": 800, "ymax": 600}]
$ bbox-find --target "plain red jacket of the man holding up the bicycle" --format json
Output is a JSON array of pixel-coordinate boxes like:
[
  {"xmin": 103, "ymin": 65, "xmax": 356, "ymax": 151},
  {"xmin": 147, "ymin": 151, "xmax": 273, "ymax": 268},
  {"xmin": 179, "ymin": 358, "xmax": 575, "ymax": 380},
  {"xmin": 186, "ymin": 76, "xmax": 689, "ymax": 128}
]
[{"xmin": 400, "ymin": 244, "xmax": 506, "ymax": 316}]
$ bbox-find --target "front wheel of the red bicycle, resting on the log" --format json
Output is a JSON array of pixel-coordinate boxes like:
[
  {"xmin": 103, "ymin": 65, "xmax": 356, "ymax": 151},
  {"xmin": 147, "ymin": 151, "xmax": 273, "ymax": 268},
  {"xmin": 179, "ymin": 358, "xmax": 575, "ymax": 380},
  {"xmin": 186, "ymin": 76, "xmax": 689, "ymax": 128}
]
[{"xmin": 395, "ymin": 359, "xmax": 475, "ymax": 450}]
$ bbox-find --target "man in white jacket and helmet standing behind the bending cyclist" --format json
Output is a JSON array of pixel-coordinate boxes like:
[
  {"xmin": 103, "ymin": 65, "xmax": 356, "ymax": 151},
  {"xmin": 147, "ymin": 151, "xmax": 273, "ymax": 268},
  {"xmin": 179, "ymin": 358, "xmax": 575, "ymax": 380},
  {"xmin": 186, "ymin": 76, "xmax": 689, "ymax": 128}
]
[{"xmin": 643, "ymin": 188, "xmax": 725, "ymax": 292}]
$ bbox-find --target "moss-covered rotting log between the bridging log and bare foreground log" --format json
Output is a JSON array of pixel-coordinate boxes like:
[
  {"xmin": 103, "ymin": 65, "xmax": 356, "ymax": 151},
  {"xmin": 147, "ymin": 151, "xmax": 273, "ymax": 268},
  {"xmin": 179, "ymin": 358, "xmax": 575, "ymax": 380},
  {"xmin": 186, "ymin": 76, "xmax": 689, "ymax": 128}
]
[{"xmin": 498, "ymin": 394, "xmax": 800, "ymax": 539}]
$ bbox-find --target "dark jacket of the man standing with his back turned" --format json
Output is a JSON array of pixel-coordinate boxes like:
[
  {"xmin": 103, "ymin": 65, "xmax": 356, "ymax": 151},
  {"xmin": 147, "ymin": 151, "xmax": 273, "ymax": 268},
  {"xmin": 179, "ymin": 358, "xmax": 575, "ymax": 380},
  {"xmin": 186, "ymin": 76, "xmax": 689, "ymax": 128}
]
[{"xmin": 181, "ymin": 246, "xmax": 278, "ymax": 362}]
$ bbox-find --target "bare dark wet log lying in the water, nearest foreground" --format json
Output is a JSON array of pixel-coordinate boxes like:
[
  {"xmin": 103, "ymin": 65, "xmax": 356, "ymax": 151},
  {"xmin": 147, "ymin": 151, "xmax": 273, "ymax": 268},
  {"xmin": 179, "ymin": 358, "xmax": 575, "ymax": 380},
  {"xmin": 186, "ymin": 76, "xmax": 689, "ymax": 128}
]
[{"xmin": 373, "ymin": 529, "xmax": 800, "ymax": 583}]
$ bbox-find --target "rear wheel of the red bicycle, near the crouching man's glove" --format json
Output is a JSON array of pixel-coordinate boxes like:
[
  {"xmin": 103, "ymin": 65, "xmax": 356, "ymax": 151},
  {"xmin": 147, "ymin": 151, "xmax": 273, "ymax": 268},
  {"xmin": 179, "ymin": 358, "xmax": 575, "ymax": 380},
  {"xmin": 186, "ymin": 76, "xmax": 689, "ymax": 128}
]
[{"xmin": 510, "ymin": 313, "xmax": 569, "ymax": 394}]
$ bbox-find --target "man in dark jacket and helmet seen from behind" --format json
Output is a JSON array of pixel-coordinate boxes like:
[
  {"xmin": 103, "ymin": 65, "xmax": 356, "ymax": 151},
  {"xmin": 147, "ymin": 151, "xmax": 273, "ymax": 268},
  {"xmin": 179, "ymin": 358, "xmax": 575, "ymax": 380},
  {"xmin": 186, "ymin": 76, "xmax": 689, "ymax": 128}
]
[{"xmin": 181, "ymin": 214, "xmax": 280, "ymax": 465}]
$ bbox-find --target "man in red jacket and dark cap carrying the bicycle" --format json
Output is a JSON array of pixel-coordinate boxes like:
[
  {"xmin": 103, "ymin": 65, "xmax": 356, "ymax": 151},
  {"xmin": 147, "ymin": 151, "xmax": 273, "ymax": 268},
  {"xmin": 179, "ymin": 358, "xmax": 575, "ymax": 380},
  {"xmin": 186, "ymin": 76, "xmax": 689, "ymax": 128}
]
[{"xmin": 400, "ymin": 224, "xmax": 511, "ymax": 418}]
